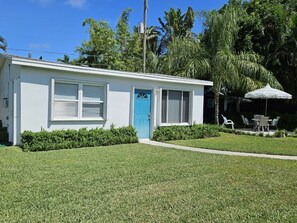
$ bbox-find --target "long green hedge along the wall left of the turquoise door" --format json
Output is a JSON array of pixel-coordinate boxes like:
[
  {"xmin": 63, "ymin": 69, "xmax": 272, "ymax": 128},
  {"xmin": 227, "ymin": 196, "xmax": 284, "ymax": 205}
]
[{"xmin": 21, "ymin": 126, "xmax": 138, "ymax": 151}]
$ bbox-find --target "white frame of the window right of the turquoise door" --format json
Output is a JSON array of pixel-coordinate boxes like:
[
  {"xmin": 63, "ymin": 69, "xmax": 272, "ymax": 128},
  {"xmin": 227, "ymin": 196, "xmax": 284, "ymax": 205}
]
[{"xmin": 160, "ymin": 88, "xmax": 193, "ymax": 126}]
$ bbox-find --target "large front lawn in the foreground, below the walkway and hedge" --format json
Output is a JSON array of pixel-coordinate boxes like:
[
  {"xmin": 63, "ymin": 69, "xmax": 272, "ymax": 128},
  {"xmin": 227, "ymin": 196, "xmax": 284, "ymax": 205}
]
[{"xmin": 0, "ymin": 144, "xmax": 297, "ymax": 223}]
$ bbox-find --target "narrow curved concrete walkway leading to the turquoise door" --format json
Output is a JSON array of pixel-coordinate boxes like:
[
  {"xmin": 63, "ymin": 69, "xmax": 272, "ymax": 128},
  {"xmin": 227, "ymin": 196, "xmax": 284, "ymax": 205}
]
[{"xmin": 139, "ymin": 140, "xmax": 297, "ymax": 160}]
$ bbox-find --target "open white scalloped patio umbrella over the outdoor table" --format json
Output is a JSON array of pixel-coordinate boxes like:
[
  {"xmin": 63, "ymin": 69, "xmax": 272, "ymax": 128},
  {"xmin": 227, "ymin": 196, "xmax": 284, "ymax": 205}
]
[{"xmin": 244, "ymin": 84, "xmax": 292, "ymax": 115}]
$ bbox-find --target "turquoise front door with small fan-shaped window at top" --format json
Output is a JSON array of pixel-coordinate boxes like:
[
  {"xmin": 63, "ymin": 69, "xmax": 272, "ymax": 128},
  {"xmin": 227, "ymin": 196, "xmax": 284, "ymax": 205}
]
[{"xmin": 134, "ymin": 89, "xmax": 151, "ymax": 139}]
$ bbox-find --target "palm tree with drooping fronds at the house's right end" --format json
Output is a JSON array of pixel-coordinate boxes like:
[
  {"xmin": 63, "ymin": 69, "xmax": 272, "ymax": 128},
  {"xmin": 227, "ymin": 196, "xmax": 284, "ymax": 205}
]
[{"xmin": 162, "ymin": 7, "xmax": 281, "ymax": 124}]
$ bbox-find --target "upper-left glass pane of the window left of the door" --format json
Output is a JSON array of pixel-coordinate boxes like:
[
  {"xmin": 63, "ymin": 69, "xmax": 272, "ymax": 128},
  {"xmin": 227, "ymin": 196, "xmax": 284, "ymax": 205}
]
[{"xmin": 54, "ymin": 83, "xmax": 78, "ymax": 100}]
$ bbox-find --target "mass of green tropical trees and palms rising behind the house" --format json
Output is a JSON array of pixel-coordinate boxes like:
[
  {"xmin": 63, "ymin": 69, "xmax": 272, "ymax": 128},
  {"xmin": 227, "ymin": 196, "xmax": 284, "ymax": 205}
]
[{"xmin": 72, "ymin": 0, "xmax": 297, "ymax": 123}]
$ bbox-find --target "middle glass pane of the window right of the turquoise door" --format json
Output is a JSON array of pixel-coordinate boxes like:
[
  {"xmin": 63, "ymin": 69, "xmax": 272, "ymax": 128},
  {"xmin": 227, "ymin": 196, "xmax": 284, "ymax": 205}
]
[{"xmin": 168, "ymin": 91, "xmax": 182, "ymax": 123}]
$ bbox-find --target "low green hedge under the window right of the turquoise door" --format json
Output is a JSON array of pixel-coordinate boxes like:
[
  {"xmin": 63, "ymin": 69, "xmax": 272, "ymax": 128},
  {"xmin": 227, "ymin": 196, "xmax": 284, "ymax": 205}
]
[{"xmin": 153, "ymin": 124, "xmax": 220, "ymax": 142}]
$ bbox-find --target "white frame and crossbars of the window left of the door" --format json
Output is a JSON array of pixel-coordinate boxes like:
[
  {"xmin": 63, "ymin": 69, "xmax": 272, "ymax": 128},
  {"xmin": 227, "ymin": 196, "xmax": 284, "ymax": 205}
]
[{"xmin": 51, "ymin": 78, "xmax": 109, "ymax": 121}]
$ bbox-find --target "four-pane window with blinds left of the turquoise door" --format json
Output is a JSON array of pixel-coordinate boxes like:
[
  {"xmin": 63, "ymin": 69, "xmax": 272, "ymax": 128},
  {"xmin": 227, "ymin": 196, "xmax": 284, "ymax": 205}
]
[{"xmin": 53, "ymin": 82, "xmax": 106, "ymax": 120}]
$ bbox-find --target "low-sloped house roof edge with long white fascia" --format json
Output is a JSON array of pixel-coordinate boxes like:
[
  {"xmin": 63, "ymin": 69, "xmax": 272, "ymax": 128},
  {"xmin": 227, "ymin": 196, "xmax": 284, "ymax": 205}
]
[{"xmin": 0, "ymin": 54, "xmax": 213, "ymax": 86}]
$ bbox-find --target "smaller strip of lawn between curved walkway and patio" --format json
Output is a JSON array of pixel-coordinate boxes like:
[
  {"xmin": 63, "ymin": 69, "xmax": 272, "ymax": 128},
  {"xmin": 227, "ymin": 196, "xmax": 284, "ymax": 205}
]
[{"xmin": 168, "ymin": 133, "xmax": 297, "ymax": 156}]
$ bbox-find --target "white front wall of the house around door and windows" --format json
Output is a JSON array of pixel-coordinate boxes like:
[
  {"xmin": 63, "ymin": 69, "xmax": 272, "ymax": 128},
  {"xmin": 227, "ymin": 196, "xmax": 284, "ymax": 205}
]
[{"xmin": 11, "ymin": 66, "xmax": 204, "ymax": 144}]
